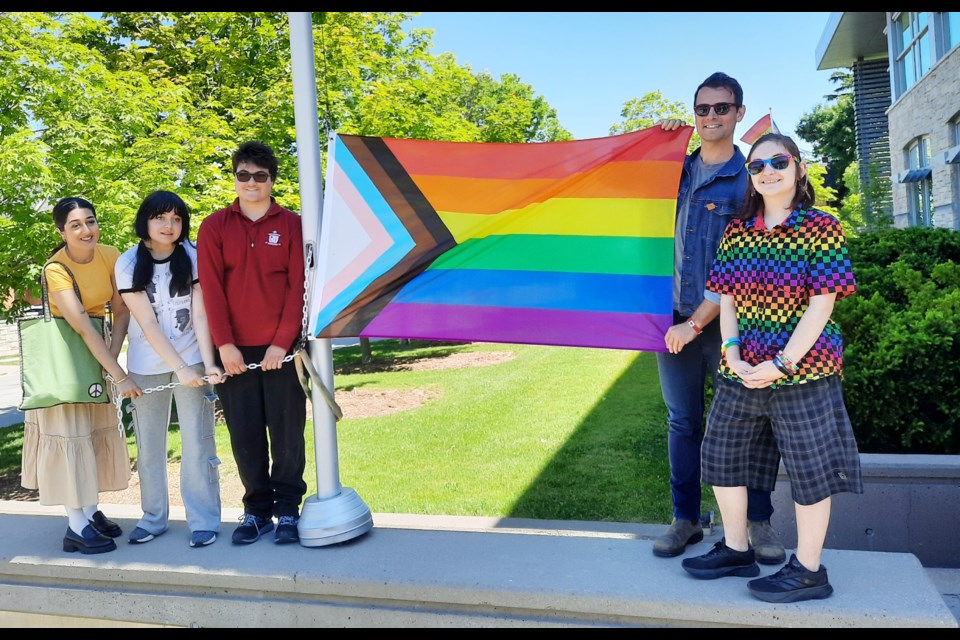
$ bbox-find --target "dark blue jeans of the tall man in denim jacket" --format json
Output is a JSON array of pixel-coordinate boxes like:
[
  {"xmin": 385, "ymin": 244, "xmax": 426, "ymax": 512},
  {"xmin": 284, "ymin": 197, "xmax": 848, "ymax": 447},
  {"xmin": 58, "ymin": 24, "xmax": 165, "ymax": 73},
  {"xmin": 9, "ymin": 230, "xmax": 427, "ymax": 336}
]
[{"xmin": 657, "ymin": 312, "xmax": 773, "ymax": 522}]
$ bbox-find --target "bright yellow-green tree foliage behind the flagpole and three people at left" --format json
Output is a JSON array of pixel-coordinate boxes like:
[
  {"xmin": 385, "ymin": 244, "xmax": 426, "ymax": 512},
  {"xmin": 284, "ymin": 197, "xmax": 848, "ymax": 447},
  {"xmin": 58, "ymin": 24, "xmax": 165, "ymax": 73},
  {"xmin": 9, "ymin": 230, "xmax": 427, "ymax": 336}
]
[{"xmin": 0, "ymin": 11, "xmax": 570, "ymax": 318}]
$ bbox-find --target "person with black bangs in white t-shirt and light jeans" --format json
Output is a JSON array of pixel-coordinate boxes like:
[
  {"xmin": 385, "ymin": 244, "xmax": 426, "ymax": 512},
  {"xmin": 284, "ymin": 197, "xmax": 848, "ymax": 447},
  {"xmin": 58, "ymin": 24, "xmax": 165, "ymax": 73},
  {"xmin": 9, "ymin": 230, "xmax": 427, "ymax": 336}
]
[{"xmin": 116, "ymin": 190, "xmax": 223, "ymax": 547}]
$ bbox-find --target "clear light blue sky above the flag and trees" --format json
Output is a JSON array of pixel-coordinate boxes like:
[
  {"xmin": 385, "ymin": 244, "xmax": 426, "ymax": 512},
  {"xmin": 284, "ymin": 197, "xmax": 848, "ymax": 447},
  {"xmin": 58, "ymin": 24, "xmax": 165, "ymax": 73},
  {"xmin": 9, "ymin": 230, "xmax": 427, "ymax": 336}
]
[{"xmin": 405, "ymin": 11, "xmax": 836, "ymax": 154}]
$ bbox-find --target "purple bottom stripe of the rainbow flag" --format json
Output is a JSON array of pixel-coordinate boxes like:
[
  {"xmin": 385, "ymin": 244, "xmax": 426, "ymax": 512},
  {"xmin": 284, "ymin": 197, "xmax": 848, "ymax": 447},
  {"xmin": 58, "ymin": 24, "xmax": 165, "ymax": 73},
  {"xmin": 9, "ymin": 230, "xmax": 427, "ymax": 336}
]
[{"xmin": 360, "ymin": 302, "xmax": 673, "ymax": 352}]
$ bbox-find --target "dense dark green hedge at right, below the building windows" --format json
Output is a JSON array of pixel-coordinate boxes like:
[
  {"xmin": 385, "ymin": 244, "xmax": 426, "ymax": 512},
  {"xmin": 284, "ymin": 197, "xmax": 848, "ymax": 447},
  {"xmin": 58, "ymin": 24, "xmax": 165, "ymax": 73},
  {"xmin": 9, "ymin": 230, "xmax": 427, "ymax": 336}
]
[{"xmin": 834, "ymin": 228, "xmax": 960, "ymax": 454}]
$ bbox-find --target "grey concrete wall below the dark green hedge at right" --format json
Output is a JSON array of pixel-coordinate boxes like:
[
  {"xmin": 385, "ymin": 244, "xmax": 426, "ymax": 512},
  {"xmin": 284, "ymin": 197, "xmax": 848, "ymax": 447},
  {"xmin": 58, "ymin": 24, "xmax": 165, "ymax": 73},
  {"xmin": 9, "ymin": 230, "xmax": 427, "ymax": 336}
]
[{"xmin": 771, "ymin": 453, "xmax": 960, "ymax": 568}]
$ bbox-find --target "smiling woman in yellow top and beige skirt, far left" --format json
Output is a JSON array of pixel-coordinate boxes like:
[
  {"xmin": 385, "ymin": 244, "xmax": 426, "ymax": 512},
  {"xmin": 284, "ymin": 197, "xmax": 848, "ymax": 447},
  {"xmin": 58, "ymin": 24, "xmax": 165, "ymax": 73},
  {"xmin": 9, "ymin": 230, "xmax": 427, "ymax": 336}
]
[{"xmin": 20, "ymin": 197, "xmax": 142, "ymax": 554}]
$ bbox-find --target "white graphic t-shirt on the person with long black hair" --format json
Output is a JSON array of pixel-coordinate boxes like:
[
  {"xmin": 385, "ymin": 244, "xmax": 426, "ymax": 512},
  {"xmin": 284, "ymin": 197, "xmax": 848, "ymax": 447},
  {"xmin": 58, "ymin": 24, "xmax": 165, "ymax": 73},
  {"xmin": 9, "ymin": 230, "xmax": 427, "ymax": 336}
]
[{"xmin": 114, "ymin": 242, "xmax": 203, "ymax": 375}]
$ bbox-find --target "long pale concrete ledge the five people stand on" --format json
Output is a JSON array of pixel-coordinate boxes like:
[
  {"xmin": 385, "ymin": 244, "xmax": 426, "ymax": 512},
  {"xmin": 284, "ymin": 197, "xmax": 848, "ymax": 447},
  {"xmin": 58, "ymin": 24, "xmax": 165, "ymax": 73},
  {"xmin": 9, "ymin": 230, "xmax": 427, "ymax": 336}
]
[{"xmin": 0, "ymin": 501, "xmax": 957, "ymax": 628}]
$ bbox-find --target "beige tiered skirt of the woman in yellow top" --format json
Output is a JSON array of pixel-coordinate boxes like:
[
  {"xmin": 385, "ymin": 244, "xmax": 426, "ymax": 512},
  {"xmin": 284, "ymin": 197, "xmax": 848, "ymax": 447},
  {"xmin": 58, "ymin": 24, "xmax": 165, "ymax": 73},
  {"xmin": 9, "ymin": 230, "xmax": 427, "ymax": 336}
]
[{"xmin": 20, "ymin": 403, "xmax": 130, "ymax": 509}]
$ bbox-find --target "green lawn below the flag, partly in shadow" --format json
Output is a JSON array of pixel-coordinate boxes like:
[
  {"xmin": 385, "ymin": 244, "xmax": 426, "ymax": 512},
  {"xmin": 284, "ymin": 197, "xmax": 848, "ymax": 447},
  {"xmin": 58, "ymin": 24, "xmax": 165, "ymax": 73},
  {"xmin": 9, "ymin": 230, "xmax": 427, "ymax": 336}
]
[{"xmin": 0, "ymin": 340, "xmax": 716, "ymax": 523}]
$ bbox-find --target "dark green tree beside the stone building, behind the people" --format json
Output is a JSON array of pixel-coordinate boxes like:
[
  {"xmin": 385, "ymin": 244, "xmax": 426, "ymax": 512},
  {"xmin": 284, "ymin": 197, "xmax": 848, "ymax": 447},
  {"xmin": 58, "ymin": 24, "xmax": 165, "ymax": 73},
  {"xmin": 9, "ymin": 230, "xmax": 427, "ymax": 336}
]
[{"xmin": 796, "ymin": 70, "xmax": 857, "ymax": 206}]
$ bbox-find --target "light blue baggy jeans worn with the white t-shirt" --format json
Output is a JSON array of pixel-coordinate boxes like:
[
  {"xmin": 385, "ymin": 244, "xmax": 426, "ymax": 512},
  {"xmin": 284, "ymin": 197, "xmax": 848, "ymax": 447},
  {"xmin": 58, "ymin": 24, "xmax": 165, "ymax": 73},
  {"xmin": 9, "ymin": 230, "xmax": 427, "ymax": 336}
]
[{"xmin": 130, "ymin": 363, "xmax": 220, "ymax": 535}]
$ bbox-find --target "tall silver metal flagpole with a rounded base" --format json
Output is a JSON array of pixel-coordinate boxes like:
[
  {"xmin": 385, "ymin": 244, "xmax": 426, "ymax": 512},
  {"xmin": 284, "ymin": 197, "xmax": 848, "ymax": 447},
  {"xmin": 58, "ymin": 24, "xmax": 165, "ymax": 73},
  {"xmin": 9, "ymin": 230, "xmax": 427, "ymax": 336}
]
[{"xmin": 287, "ymin": 12, "xmax": 373, "ymax": 547}]
